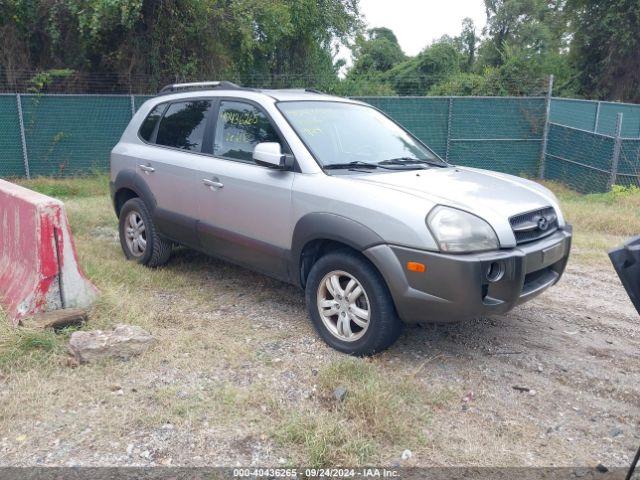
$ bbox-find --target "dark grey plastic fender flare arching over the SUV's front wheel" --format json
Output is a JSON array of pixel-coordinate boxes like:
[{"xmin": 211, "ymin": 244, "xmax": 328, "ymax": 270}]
[{"xmin": 290, "ymin": 213, "xmax": 385, "ymax": 286}]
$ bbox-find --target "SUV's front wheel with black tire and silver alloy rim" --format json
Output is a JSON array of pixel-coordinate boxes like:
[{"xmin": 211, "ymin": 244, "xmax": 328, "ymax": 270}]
[{"xmin": 305, "ymin": 250, "xmax": 403, "ymax": 356}]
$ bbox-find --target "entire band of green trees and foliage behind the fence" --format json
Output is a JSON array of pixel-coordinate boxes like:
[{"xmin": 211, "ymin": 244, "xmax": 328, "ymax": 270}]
[{"xmin": 0, "ymin": 0, "xmax": 640, "ymax": 102}]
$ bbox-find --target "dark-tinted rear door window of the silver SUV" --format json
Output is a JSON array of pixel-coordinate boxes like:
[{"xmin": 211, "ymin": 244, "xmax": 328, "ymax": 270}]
[{"xmin": 156, "ymin": 100, "xmax": 211, "ymax": 152}]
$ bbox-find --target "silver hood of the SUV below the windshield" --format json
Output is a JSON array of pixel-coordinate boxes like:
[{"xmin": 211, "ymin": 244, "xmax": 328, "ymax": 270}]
[{"xmin": 349, "ymin": 167, "xmax": 560, "ymax": 227}]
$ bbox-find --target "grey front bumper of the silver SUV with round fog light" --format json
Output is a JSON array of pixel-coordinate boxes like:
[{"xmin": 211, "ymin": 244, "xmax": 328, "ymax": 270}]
[{"xmin": 364, "ymin": 225, "xmax": 571, "ymax": 323}]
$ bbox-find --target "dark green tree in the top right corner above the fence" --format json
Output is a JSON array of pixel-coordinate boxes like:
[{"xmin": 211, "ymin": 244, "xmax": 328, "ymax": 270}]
[{"xmin": 568, "ymin": 0, "xmax": 640, "ymax": 102}]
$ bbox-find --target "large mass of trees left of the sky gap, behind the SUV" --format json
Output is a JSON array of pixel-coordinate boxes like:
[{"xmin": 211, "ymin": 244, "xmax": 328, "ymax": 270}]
[{"xmin": 0, "ymin": 0, "xmax": 361, "ymax": 91}]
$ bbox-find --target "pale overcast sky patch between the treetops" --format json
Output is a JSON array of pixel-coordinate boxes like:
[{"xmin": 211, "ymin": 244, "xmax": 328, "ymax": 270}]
[{"xmin": 360, "ymin": 0, "xmax": 487, "ymax": 56}]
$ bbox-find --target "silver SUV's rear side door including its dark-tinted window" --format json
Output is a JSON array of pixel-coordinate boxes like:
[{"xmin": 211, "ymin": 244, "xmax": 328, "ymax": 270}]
[{"xmin": 137, "ymin": 98, "xmax": 213, "ymax": 247}]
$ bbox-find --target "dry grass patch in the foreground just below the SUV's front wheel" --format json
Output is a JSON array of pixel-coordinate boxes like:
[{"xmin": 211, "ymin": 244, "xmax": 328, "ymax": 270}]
[{"xmin": 276, "ymin": 358, "xmax": 452, "ymax": 467}]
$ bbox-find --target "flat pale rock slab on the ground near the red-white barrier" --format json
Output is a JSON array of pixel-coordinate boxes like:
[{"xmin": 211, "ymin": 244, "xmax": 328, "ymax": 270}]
[{"xmin": 69, "ymin": 325, "xmax": 155, "ymax": 363}]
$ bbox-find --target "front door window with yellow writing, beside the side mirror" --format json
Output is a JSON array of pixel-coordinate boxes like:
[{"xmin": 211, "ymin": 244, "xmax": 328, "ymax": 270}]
[{"xmin": 213, "ymin": 101, "xmax": 284, "ymax": 162}]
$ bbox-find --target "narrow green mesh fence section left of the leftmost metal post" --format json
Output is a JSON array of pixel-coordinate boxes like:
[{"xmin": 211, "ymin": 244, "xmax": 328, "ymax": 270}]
[{"xmin": 0, "ymin": 95, "xmax": 26, "ymax": 177}]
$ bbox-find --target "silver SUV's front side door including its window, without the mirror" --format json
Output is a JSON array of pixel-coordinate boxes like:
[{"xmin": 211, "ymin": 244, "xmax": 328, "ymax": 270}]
[{"xmin": 197, "ymin": 98, "xmax": 295, "ymax": 279}]
